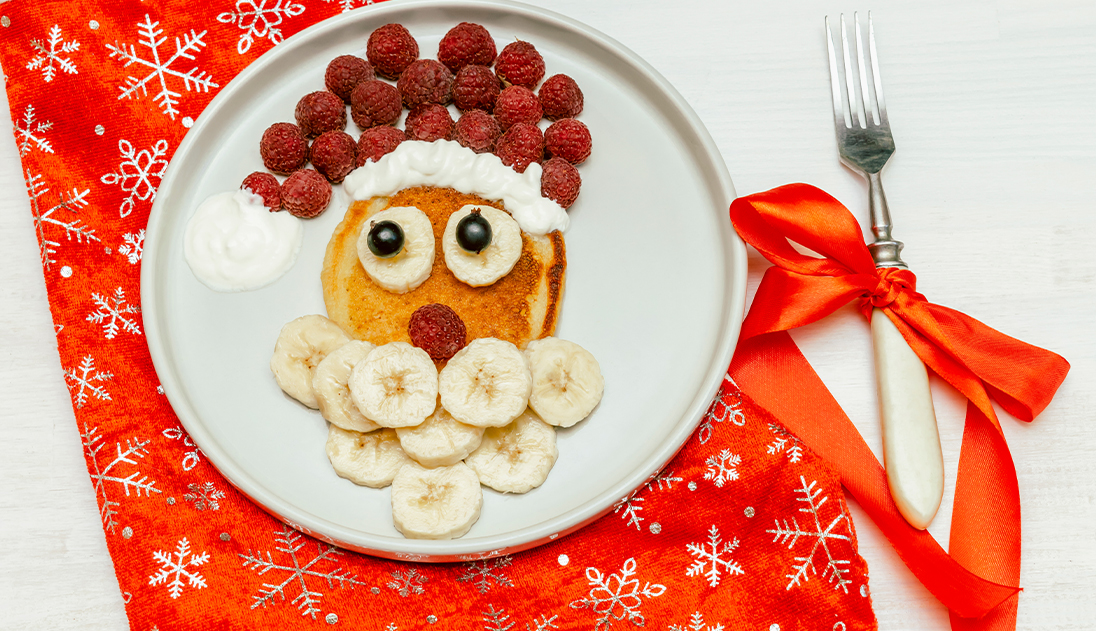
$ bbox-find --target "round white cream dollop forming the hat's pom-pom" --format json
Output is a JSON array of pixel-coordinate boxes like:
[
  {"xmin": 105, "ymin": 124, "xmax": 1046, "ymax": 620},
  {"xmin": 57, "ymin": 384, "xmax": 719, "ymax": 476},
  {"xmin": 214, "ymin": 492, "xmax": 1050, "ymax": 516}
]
[{"xmin": 183, "ymin": 191, "xmax": 305, "ymax": 291}]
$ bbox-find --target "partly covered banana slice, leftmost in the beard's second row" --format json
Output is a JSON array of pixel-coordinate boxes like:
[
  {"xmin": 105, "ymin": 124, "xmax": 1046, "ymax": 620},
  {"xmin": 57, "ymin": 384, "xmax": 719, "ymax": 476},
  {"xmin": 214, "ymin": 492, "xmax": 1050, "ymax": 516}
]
[{"xmin": 327, "ymin": 425, "xmax": 411, "ymax": 489}]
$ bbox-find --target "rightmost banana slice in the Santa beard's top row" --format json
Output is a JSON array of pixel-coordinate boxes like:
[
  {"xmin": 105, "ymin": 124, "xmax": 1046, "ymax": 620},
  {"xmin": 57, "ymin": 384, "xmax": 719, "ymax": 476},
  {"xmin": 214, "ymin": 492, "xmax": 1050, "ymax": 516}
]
[{"xmin": 525, "ymin": 337, "xmax": 605, "ymax": 427}]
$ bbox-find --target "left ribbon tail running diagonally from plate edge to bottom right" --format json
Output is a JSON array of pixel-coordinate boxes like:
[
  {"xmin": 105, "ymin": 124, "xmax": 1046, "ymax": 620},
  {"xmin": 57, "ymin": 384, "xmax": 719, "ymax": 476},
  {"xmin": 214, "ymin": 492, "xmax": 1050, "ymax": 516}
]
[{"xmin": 729, "ymin": 332, "xmax": 1019, "ymax": 618}]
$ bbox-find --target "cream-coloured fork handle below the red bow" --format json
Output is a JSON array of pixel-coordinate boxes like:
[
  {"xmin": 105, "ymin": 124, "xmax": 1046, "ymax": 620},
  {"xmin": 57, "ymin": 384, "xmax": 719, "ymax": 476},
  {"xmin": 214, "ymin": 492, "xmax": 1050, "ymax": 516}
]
[{"xmin": 871, "ymin": 309, "xmax": 944, "ymax": 530}]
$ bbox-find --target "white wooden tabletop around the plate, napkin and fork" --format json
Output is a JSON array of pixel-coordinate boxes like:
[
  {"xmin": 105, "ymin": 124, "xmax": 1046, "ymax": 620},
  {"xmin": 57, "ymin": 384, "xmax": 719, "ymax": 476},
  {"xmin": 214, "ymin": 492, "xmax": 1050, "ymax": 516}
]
[{"xmin": 0, "ymin": 0, "xmax": 1096, "ymax": 630}]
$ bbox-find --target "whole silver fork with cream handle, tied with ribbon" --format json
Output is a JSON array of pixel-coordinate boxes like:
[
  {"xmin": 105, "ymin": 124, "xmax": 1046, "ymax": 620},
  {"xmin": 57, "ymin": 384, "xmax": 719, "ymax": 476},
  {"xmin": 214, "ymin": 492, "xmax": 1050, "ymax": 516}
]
[{"xmin": 825, "ymin": 12, "xmax": 944, "ymax": 529}]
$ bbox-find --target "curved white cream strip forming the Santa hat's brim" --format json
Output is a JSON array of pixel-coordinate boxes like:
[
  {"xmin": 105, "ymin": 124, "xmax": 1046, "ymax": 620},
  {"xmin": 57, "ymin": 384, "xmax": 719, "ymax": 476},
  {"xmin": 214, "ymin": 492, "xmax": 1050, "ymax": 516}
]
[{"xmin": 343, "ymin": 140, "xmax": 570, "ymax": 234}]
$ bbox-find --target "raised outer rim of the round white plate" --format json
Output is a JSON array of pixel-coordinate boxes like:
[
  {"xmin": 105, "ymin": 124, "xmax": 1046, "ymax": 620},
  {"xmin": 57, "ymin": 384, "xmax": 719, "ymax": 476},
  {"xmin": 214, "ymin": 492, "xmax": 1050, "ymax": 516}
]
[{"xmin": 140, "ymin": 0, "xmax": 746, "ymax": 562}]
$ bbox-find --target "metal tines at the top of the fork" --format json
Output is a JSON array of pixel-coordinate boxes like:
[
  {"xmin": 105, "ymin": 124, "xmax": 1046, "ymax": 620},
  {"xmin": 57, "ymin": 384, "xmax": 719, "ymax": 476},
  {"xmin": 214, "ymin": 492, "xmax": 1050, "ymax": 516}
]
[{"xmin": 825, "ymin": 11, "xmax": 888, "ymax": 129}]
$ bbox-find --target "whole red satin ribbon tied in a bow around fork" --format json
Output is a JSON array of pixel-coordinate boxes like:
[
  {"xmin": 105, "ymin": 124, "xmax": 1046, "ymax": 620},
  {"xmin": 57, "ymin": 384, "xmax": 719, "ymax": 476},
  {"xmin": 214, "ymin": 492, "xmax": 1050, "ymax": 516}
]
[{"xmin": 730, "ymin": 184, "xmax": 1070, "ymax": 631}]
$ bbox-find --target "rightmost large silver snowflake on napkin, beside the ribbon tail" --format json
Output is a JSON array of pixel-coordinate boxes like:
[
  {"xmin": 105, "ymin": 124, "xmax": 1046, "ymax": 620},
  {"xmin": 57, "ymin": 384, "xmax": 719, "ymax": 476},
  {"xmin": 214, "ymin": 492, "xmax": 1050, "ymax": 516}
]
[{"xmin": 766, "ymin": 475, "xmax": 853, "ymax": 594}]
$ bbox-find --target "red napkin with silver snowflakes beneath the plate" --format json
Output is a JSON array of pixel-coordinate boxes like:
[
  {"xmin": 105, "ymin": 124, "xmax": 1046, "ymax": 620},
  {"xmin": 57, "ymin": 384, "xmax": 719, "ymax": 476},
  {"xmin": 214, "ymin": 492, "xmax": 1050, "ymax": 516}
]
[{"xmin": 0, "ymin": 0, "xmax": 876, "ymax": 631}]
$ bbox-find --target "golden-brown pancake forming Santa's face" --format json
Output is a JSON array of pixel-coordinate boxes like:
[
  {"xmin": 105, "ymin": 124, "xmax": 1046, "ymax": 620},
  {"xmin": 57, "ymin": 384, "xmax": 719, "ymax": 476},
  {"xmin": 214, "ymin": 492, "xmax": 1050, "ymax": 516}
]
[{"xmin": 320, "ymin": 186, "xmax": 567, "ymax": 357}]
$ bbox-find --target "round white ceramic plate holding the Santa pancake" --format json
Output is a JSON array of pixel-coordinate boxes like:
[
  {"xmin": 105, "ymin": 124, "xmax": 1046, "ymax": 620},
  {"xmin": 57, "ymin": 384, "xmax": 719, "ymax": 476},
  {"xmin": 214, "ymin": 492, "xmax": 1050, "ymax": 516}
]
[{"xmin": 141, "ymin": 0, "xmax": 746, "ymax": 561}]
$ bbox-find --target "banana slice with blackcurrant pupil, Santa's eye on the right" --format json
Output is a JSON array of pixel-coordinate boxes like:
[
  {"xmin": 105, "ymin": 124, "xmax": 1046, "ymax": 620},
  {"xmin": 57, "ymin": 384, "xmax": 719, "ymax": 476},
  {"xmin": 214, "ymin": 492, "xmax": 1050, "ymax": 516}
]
[{"xmin": 442, "ymin": 204, "xmax": 522, "ymax": 287}]
